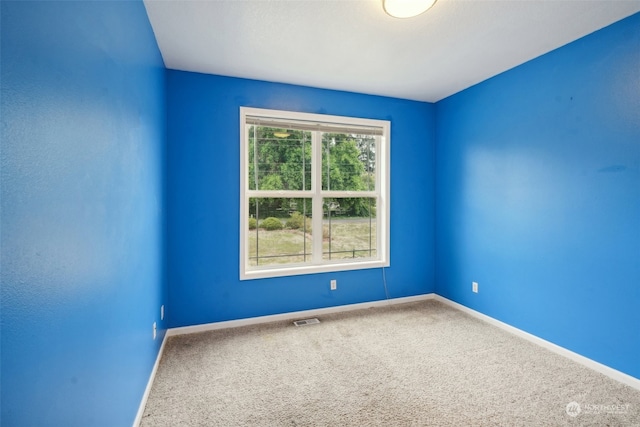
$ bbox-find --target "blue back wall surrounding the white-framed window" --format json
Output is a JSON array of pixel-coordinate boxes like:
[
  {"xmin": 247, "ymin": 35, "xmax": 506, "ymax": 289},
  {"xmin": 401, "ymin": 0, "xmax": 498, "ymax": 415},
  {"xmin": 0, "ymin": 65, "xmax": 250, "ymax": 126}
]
[{"xmin": 167, "ymin": 71, "xmax": 435, "ymax": 327}]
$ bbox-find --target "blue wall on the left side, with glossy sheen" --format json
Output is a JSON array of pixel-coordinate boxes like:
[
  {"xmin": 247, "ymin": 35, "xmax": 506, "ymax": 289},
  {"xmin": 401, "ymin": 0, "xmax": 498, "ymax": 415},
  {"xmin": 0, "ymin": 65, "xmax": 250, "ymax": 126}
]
[{"xmin": 0, "ymin": 1, "xmax": 166, "ymax": 427}]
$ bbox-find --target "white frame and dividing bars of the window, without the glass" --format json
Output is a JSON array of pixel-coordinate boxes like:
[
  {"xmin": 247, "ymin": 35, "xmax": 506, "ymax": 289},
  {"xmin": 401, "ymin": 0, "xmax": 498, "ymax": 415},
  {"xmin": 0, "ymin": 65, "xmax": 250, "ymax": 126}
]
[{"xmin": 240, "ymin": 107, "xmax": 391, "ymax": 280}]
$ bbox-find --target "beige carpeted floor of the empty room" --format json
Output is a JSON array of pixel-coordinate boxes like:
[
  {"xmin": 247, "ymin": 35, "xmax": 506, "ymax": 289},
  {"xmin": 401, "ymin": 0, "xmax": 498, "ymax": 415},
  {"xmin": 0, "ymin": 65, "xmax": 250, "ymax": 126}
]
[{"xmin": 141, "ymin": 300, "xmax": 640, "ymax": 427}]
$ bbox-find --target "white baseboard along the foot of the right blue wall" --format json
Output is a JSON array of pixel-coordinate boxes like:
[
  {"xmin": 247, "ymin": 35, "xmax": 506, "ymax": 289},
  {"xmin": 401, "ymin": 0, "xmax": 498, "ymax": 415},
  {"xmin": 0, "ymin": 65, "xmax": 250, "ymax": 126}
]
[{"xmin": 434, "ymin": 295, "xmax": 640, "ymax": 390}]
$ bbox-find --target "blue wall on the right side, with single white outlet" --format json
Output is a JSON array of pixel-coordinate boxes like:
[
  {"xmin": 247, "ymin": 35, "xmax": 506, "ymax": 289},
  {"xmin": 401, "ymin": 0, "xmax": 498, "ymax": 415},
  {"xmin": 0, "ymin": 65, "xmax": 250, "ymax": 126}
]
[{"xmin": 436, "ymin": 14, "xmax": 640, "ymax": 378}]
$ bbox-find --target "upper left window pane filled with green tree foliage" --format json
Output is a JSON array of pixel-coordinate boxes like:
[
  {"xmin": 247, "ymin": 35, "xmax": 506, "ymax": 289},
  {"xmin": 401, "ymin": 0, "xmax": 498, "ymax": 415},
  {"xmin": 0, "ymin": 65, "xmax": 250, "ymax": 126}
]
[{"xmin": 248, "ymin": 126, "xmax": 311, "ymax": 190}]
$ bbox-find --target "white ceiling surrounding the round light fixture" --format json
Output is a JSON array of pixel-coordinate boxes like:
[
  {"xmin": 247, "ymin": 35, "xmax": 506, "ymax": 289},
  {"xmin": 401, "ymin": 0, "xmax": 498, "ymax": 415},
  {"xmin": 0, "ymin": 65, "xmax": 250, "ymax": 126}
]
[{"xmin": 144, "ymin": 0, "xmax": 640, "ymax": 102}]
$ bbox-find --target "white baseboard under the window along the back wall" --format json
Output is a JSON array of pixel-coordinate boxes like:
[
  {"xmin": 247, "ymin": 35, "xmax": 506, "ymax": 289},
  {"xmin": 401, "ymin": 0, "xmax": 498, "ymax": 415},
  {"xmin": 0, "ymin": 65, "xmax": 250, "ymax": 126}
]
[{"xmin": 167, "ymin": 294, "xmax": 435, "ymax": 336}]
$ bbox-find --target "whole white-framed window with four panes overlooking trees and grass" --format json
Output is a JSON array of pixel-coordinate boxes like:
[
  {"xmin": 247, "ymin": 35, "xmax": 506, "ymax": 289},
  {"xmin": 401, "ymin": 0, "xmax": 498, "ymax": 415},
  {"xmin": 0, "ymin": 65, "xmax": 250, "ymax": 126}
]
[{"xmin": 240, "ymin": 107, "xmax": 390, "ymax": 279}]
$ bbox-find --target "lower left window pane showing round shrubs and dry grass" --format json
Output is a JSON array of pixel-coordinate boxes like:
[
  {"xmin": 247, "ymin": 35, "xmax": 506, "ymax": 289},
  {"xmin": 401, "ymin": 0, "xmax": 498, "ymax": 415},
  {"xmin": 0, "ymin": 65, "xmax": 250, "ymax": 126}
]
[{"xmin": 248, "ymin": 198, "xmax": 313, "ymax": 266}]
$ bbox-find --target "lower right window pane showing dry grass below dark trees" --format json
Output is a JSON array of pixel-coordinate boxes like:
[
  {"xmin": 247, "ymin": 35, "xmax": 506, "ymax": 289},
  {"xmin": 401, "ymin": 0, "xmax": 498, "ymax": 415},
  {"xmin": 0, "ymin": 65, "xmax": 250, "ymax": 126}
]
[{"xmin": 322, "ymin": 197, "xmax": 377, "ymax": 260}]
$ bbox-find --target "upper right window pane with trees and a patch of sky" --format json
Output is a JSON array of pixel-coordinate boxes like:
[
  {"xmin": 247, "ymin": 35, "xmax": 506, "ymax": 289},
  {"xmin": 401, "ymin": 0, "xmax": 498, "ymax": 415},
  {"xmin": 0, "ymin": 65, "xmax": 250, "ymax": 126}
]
[{"xmin": 322, "ymin": 133, "xmax": 376, "ymax": 191}]
